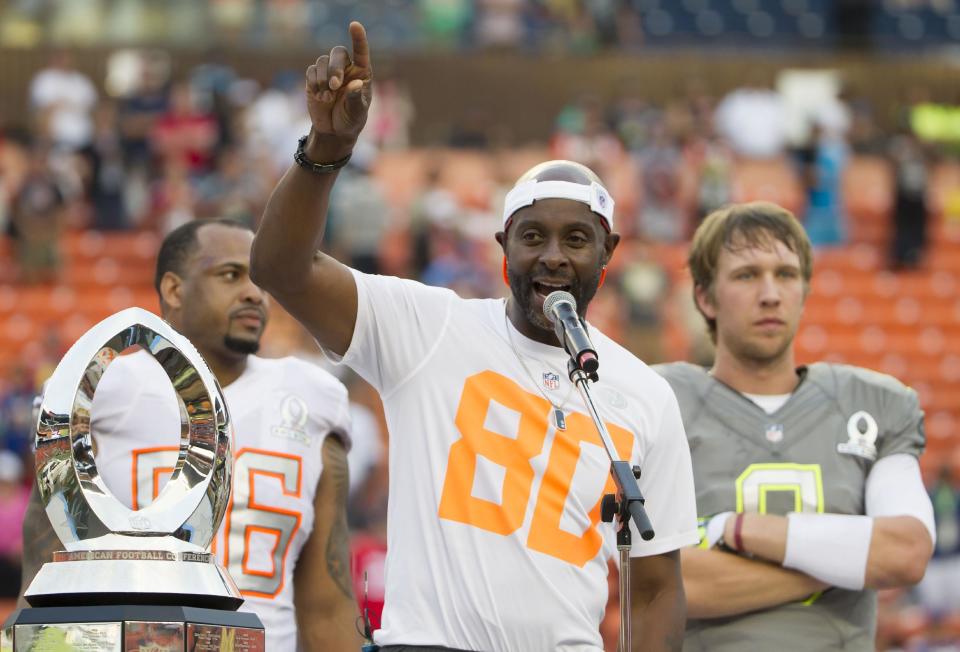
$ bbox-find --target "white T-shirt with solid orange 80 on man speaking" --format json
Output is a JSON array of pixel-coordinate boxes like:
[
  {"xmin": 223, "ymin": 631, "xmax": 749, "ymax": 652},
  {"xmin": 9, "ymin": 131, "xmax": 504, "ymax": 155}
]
[{"xmin": 332, "ymin": 272, "xmax": 697, "ymax": 652}]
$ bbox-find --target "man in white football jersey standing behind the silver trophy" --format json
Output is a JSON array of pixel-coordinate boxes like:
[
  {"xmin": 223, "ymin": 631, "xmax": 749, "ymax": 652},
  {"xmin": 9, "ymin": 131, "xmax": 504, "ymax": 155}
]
[{"xmin": 23, "ymin": 220, "xmax": 360, "ymax": 651}]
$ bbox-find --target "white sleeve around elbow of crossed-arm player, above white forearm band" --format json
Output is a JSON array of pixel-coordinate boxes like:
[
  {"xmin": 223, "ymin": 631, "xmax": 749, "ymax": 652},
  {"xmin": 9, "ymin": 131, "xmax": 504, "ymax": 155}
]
[{"xmin": 866, "ymin": 453, "xmax": 937, "ymax": 544}]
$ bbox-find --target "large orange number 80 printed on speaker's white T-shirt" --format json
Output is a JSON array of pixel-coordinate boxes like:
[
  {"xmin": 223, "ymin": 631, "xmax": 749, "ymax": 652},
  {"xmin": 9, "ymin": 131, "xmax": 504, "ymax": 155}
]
[{"xmin": 438, "ymin": 371, "xmax": 634, "ymax": 567}]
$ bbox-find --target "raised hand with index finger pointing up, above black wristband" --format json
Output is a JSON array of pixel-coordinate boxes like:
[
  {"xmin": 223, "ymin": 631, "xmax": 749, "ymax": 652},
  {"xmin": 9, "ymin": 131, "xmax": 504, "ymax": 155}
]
[{"xmin": 305, "ymin": 21, "xmax": 373, "ymax": 162}]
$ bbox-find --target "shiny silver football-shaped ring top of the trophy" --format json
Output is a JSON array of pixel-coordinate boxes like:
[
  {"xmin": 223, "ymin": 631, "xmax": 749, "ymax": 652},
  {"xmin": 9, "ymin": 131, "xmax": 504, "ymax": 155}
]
[{"xmin": 36, "ymin": 308, "xmax": 232, "ymax": 551}]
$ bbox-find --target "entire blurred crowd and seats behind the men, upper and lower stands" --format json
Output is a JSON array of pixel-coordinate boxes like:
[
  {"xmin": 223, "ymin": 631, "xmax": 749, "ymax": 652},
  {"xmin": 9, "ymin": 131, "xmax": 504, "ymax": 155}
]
[{"xmin": 0, "ymin": 0, "xmax": 960, "ymax": 651}]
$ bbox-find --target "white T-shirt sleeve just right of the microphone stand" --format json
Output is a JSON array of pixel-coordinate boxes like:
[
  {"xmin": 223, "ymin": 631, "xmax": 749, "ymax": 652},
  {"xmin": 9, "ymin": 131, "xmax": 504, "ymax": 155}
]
[{"xmin": 630, "ymin": 381, "xmax": 699, "ymax": 557}]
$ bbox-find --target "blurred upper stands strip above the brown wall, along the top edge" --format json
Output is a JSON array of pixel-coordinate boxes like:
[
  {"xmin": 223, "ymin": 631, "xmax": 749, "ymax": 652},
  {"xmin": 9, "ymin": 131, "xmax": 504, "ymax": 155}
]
[{"xmin": 0, "ymin": 0, "xmax": 960, "ymax": 53}]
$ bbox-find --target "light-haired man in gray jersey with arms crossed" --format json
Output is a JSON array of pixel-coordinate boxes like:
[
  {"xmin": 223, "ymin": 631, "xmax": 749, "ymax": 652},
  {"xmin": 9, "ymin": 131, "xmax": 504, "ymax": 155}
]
[{"xmin": 658, "ymin": 202, "xmax": 934, "ymax": 652}]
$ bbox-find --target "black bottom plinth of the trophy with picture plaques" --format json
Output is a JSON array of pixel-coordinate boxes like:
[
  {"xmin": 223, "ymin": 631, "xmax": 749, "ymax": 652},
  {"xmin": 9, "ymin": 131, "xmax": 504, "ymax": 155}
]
[{"xmin": 0, "ymin": 605, "xmax": 266, "ymax": 652}]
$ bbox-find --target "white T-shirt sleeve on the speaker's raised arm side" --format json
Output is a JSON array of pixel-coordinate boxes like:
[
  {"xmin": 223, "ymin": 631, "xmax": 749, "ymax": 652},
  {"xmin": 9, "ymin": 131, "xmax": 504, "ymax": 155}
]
[{"xmin": 338, "ymin": 270, "xmax": 456, "ymax": 399}]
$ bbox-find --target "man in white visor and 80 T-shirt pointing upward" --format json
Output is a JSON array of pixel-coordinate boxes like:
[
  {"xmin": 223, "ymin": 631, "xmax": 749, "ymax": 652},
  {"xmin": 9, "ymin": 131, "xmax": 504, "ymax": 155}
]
[{"xmin": 251, "ymin": 23, "xmax": 697, "ymax": 652}]
